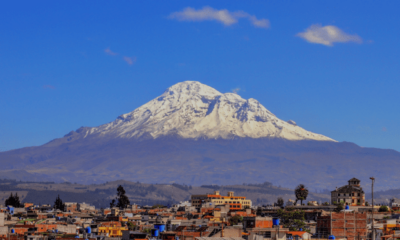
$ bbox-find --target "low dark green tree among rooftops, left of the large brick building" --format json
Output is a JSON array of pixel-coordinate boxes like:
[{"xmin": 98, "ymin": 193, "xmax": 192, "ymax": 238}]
[{"xmin": 277, "ymin": 208, "xmax": 306, "ymax": 231}]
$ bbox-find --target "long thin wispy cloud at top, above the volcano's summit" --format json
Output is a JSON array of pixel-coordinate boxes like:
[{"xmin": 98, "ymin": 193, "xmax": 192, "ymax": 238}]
[{"xmin": 169, "ymin": 6, "xmax": 270, "ymax": 28}]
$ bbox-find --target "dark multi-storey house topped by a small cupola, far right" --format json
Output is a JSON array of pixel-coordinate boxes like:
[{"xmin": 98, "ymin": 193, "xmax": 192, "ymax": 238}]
[{"xmin": 331, "ymin": 178, "xmax": 365, "ymax": 206}]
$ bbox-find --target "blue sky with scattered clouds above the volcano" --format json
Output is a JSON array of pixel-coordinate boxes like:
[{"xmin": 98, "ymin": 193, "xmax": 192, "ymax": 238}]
[{"xmin": 0, "ymin": 1, "xmax": 400, "ymax": 151}]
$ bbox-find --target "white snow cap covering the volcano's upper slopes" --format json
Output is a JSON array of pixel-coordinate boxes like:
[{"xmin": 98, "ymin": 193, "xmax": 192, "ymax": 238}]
[{"xmin": 77, "ymin": 81, "xmax": 334, "ymax": 141}]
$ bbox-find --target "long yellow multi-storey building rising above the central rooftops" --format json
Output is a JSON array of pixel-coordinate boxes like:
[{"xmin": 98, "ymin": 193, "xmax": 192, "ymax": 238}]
[{"xmin": 191, "ymin": 191, "xmax": 251, "ymax": 210}]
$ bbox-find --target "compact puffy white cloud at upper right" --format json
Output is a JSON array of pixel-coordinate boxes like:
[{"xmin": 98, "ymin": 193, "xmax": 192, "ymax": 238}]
[{"xmin": 296, "ymin": 24, "xmax": 362, "ymax": 46}]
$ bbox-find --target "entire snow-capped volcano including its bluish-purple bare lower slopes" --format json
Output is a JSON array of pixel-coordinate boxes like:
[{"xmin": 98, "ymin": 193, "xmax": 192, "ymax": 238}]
[{"xmin": 6, "ymin": 81, "xmax": 400, "ymax": 189}]
